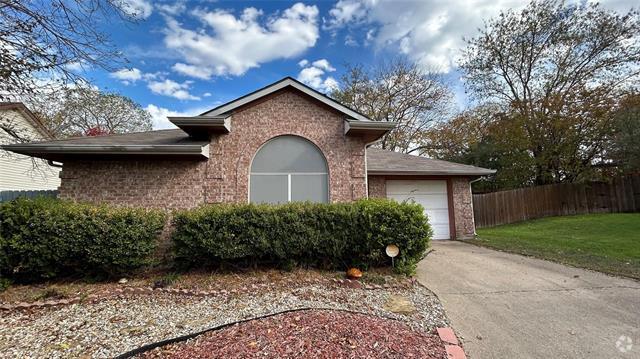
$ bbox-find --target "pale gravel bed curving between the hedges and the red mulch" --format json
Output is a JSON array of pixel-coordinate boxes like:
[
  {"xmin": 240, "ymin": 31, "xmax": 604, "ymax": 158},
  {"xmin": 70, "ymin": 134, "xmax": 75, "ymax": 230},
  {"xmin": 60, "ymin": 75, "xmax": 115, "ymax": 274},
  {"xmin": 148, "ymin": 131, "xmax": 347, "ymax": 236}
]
[{"xmin": 0, "ymin": 283, "xmax": 448, "ymax": 358}]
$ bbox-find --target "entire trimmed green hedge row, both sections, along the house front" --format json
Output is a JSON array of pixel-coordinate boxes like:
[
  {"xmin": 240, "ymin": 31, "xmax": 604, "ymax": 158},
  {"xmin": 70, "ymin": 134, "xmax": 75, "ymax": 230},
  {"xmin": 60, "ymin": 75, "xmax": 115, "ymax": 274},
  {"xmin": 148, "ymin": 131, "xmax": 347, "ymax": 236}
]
[{"xmin": 0, "ymin": 198, "xmax": 431, "ymax": 282}]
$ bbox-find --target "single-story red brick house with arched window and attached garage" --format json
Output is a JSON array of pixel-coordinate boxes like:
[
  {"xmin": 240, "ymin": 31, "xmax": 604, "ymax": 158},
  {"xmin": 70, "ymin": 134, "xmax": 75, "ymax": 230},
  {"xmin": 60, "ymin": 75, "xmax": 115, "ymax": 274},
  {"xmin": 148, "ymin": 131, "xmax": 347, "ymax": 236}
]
[{"xmin": 4, "ymin": 77, "xmax": 494, "ymax": 239}]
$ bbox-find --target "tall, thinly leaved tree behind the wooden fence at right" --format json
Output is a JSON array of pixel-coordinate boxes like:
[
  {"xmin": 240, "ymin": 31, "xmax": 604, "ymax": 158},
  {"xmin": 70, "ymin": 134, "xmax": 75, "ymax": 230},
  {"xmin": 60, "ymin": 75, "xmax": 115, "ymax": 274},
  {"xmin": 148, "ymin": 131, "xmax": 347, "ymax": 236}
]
[{"xmin": 460, "ymin": 0, "xmax": 640, "ymax": 184}]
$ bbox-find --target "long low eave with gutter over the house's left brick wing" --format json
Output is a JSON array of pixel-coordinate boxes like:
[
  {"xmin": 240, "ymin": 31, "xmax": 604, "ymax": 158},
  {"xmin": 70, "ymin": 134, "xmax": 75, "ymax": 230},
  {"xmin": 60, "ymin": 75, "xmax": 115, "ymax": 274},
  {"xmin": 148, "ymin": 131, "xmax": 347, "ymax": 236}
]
[{"xmin": 0, "ymin": 143, "xmax": 209, "ymax": 161}]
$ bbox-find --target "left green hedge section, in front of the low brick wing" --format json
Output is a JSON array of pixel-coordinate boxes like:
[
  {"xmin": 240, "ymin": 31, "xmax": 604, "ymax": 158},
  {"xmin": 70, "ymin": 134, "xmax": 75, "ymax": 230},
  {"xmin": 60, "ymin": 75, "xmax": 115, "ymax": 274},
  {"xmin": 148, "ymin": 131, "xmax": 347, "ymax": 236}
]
[{"xmin": 0, "ymin": 198, "xmax": 165, "ymax": 281}]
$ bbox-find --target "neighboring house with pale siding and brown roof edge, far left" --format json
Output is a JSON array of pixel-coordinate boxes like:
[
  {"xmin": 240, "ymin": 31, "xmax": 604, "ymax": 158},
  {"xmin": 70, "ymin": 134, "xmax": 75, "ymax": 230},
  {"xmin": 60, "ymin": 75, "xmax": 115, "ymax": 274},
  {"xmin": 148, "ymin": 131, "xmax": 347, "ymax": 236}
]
[{"xmin": 0, "ymin": 102, "xmax": 60, "ymax": 191}]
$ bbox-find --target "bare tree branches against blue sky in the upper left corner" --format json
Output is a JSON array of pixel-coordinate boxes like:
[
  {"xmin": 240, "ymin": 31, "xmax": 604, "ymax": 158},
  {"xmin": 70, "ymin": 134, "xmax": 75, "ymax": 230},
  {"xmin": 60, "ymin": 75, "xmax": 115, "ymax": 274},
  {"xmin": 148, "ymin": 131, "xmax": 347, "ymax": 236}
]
[{"xmin": 0, "ymin": 0, "xmax": 145, "ymax": 141}]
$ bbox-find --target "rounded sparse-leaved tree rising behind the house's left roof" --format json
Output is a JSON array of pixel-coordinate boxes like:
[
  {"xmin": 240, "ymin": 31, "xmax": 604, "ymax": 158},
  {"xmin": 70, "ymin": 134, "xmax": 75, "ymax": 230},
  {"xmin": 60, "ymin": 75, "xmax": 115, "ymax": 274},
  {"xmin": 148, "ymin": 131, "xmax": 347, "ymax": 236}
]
[{"xmin": 39, "ymin": 87, "xmax": 152, "ymax": 137}]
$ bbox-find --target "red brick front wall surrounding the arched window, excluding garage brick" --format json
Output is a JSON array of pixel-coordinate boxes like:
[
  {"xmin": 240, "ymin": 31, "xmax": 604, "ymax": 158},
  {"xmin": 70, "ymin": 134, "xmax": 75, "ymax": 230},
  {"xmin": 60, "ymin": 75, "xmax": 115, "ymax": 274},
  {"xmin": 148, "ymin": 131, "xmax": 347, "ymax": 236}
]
[{"xmin": 60, "ymin": 90, "xmax": 367, "ymax": 209}]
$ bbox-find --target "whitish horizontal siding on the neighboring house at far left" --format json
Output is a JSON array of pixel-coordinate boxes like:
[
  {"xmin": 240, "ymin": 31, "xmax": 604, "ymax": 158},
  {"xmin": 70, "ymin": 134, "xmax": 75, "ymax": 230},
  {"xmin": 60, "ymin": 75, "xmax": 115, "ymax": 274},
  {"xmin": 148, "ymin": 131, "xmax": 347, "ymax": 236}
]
[{"xmin": 0, "ymin": 110, "xmax": 60, "ymax": 191}]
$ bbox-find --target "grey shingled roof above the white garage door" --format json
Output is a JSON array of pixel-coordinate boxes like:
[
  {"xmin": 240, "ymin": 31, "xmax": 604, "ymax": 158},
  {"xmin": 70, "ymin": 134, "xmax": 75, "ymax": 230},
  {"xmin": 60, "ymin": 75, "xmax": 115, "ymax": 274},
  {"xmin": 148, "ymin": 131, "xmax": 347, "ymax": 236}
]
[{"xmin": 367, "ymin": 148, "xmax": 496, "ymax": 176}]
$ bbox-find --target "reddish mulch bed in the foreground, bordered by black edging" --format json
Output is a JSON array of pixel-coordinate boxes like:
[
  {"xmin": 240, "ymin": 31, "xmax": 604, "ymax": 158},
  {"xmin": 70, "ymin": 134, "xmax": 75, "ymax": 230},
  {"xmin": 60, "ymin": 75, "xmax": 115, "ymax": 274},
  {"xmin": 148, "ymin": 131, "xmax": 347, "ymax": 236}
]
[{"xmin": 139, "ymin": 310, "xmax": 447, "ymax": 359}]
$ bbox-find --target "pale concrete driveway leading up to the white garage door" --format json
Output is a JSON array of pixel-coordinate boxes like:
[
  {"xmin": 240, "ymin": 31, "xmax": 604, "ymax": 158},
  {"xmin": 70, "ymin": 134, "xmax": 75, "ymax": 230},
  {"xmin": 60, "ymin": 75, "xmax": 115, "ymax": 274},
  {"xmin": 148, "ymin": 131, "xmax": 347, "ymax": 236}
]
[{"xmin": 418, "ymin": 241, "xmax": 640, "ymax": 359}]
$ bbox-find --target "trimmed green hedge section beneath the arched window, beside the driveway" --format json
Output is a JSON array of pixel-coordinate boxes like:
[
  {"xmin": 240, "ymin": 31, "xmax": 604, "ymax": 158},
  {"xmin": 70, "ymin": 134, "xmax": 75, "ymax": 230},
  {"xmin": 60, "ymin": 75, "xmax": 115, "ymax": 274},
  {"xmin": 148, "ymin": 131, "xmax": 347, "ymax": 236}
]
[{"xmin": 172, "ymin": 199, "xmax": 431, "ymax": 274}]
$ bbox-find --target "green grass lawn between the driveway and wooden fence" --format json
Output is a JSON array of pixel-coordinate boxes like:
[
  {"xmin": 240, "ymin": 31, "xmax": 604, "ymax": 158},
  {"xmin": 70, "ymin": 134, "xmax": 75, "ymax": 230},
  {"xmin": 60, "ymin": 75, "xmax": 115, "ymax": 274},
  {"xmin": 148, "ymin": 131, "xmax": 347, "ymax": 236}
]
[{"xmin": 470, "ymin": 213, "xmax": 640, "ymax": 279}]
